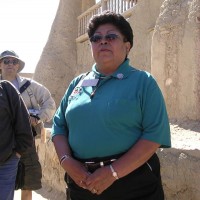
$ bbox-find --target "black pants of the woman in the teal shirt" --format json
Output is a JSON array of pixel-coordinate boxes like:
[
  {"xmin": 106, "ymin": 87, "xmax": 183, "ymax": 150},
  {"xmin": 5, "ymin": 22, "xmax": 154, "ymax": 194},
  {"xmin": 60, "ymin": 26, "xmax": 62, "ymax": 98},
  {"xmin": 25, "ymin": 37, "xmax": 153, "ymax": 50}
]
[{"xmin": 67, "ymin": 154, "xmax": 164, "ymax": 200}]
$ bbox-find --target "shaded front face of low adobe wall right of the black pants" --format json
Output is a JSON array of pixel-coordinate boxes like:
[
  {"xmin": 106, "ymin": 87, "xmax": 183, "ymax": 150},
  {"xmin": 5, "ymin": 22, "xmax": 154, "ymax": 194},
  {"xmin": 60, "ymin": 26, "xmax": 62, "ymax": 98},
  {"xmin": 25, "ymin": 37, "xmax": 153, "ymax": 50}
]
[{"xmin": 158, "ymin": 148, "xmax": 200, "ymax": 200}]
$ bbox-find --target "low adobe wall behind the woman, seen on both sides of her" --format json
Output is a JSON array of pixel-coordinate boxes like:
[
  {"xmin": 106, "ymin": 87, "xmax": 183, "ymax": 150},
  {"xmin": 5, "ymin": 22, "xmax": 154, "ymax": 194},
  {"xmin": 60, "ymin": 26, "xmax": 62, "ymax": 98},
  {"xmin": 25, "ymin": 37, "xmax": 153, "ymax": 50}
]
[{"xmin": 36, "ymin": 126, "xmax": 200, "ymax": 200}]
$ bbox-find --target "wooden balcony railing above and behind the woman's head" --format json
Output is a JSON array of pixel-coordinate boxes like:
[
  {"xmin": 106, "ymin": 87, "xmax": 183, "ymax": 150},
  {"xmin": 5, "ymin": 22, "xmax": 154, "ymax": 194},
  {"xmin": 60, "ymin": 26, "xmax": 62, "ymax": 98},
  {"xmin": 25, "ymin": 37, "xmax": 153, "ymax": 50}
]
[{"xmin": 76, "ymin": 0, "xmax": 137, "ymax": 42}]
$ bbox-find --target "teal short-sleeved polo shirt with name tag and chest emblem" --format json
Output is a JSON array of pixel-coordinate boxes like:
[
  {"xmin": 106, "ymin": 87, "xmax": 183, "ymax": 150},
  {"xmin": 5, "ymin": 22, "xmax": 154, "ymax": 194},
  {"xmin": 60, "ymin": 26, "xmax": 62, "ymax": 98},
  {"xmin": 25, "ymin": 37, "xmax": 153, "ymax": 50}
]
[{"xmin": 52, "ymin": 59, "xmax": 171, "ymax": 159}]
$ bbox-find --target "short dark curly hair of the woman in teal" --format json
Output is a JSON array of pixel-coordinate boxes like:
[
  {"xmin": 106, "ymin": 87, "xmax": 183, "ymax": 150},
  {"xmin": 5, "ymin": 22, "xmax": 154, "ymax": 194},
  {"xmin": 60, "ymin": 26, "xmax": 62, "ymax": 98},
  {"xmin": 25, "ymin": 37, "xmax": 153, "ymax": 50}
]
[{"xmin": 87, "ymin": 10, "xmax": 133, "ymax": 47}]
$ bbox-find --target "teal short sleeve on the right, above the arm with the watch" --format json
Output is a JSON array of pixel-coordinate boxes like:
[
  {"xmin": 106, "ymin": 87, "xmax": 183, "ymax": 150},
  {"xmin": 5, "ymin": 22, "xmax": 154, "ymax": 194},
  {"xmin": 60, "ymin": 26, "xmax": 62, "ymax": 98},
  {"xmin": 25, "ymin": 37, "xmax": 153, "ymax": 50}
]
[{"xmin": 142, "ymin": 76, "xmax": 171, "ymax": 147}]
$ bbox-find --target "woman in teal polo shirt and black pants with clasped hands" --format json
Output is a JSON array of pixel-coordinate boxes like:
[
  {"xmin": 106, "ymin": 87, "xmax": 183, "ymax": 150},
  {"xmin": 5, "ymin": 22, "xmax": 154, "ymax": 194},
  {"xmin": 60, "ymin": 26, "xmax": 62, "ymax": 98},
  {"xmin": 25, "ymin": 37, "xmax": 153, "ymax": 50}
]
[{"xmin": 52, "ymin": 11, "xmax": 171, "ymax": 200}]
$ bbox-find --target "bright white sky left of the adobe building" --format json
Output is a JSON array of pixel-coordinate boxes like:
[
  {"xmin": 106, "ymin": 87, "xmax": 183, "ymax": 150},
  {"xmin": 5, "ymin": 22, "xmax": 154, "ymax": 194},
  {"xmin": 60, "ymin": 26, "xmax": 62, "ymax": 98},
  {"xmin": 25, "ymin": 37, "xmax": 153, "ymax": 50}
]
[{"xmin": 0, "ymin": 0, "xmax": 59, "ymax": 73}]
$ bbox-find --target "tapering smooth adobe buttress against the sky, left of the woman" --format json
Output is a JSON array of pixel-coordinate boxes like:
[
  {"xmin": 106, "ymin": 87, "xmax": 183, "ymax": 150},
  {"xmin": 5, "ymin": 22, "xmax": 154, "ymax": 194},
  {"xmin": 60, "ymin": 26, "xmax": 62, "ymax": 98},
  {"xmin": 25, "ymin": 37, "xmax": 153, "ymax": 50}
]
[{"xmin": 34, "ymin": 0, "xmax": 82, "ymax": 106}]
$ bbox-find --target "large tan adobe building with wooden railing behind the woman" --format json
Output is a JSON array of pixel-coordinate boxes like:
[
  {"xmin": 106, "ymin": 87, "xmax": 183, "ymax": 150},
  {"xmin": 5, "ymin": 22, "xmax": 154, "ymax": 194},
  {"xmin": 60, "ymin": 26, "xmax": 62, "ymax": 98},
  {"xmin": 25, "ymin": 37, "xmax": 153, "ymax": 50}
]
[{"xmin": 34, "ymin": 0, "xmax": 200, "ymax": 120}]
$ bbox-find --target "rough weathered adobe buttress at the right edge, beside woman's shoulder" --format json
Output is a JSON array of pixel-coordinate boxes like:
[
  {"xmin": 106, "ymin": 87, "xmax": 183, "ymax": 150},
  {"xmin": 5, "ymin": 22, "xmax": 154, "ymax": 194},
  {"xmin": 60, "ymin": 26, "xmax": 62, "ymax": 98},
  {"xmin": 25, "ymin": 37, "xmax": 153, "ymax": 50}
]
[{"xmin": 151, "ymin": 0, "xmax": 200, "ymax": 120}]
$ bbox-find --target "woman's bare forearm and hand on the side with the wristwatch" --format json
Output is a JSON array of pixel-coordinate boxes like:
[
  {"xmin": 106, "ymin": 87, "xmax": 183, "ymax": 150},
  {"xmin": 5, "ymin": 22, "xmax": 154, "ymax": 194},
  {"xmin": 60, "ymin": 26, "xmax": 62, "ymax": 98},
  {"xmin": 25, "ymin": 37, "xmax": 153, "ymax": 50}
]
[{"xmin": 86, "ymin": 139, "xmax": 160, "ymax": 194}]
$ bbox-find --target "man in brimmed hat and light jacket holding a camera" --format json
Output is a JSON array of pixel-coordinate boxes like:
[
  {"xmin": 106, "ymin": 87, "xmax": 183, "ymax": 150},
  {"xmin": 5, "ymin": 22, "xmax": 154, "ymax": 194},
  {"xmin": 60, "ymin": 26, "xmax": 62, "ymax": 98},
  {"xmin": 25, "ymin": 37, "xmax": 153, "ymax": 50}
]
[{"xmin": 0, "ymin": 50, "xmax": 56, "ymax": 200}]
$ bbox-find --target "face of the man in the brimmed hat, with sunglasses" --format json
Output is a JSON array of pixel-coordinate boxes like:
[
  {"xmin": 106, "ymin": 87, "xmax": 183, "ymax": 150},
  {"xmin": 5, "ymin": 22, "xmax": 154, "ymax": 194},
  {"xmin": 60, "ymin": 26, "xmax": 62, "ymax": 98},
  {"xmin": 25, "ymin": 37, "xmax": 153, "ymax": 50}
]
[{"xmin": 0, "ymin": 57, "xmax": 19, "ymax": 76}]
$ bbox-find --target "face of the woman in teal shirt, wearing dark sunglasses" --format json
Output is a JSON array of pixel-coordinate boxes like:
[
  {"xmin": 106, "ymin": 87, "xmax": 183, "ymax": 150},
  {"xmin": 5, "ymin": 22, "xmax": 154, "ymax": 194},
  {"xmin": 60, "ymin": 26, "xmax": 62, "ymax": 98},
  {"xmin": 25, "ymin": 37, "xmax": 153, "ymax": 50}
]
[{"xmin": 90, "ymin": 24, "xmax": 130, "ymax": 73}]
